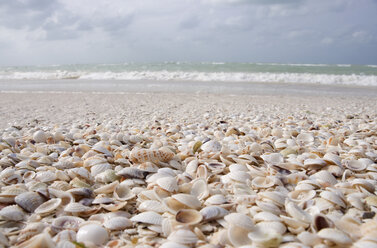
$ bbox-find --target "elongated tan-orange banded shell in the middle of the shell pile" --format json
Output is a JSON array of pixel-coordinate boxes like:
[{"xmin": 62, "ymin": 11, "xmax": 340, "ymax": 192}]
[{"xmin": 130, "ymin": 148, "xmax": 174, "ymax": 163}]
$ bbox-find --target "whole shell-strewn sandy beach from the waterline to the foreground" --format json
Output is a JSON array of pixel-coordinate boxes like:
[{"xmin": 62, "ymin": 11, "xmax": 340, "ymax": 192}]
[{"xmin": 0, "ymin": 82, "xmax": 377, "ymax": 247}]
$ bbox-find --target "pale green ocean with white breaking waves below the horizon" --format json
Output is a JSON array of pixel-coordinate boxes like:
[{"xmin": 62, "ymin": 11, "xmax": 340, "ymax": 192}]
[{"xmin": 0, "ymin": 62, "xmax": 377, "ymax": 86}]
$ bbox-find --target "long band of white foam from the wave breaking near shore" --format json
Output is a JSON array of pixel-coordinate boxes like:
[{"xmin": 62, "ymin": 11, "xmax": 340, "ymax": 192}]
[{"xmin": 0, "ymin": 70, "xmax": 377, "ymax": 86}]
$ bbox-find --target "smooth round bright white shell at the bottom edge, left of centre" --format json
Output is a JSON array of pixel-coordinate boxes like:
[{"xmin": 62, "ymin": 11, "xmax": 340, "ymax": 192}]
[{"xmin": 76, "ymin": 224, "xmax": 109, "ymax": 246}]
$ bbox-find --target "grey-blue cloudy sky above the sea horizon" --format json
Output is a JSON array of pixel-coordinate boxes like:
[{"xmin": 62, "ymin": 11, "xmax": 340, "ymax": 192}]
[{"xmin": 0, "ymin": 0, "xmax": 377, "ymax": 65}]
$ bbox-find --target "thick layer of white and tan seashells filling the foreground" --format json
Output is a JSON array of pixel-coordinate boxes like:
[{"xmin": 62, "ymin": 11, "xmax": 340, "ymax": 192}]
[{"xmin": 0, "ymin": 111, "xmax": 377, "ymax": 248}]
